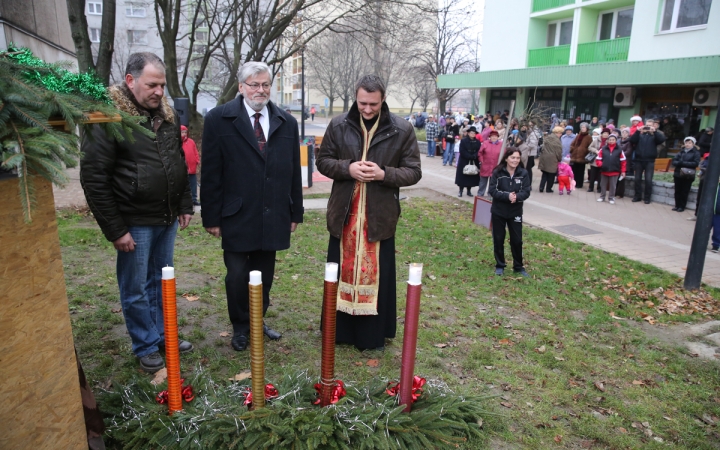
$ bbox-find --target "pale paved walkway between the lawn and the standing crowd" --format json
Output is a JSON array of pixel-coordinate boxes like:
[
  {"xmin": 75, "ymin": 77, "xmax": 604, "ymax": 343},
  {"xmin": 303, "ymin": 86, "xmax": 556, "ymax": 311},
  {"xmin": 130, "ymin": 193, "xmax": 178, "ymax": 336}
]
[{"xmin": 54, "ymin": 145, "xmax": 720, "ymax": 287}]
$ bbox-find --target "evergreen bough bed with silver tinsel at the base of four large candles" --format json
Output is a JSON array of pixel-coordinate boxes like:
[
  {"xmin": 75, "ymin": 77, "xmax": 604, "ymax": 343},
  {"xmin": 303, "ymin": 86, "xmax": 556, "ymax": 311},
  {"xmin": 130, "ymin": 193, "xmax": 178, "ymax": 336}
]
[{"xmin": 99, "ymin": 370, "xmax": 495, "ymax": 450}]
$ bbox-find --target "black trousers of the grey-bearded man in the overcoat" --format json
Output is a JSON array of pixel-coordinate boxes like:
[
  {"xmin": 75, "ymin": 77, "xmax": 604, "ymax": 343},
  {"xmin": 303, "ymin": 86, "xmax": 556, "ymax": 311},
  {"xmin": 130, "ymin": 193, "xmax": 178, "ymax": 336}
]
[{"xmin": 223, "ymin": 250, "xmax": 275, "ymax": 336}]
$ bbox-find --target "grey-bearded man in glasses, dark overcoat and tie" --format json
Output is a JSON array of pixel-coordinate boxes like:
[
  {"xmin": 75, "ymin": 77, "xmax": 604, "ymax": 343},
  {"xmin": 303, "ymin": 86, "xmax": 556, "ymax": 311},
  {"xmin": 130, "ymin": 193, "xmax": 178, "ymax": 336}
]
[{"xmin": 200, "ymin": 62, "xmax": 304, "ymax": 351}]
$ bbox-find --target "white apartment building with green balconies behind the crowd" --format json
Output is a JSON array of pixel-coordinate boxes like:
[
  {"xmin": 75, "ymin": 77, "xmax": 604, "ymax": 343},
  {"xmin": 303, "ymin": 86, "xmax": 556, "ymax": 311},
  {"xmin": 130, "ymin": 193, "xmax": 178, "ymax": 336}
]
[{"xmin": 438, "ymin": 0, "xmax": 720, "ymax": 135}]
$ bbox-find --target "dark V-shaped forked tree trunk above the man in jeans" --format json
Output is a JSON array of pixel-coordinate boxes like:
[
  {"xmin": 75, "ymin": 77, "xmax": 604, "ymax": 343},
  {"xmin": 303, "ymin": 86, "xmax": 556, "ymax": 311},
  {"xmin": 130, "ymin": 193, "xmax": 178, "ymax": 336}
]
[{"xmin": 66, "ymin": 0, "xmax": 115, "ymax": 84}]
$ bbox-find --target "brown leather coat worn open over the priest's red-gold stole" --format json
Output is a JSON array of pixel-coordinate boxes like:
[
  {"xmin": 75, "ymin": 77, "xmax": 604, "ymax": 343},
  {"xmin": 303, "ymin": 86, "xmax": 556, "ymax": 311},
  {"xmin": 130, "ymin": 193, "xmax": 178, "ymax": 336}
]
[{"xmin": 316, "ymin": 102, "xmax": 422, "ymax": 242}]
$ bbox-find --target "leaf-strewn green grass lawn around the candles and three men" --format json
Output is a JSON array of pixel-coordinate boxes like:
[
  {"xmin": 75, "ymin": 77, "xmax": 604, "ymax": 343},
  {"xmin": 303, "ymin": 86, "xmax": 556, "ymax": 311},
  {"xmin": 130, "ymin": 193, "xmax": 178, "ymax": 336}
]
[{"xmin": 58, "ymin": 198, "xmax": 720, "ymax": 449}]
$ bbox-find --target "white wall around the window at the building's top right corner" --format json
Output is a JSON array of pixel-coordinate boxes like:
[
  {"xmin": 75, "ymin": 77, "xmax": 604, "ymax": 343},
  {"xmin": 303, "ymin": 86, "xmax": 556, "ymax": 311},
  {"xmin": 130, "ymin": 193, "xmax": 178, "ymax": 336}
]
[{"xmin": 628, "ymin": 0, "xmax": 720, "ymax": 61}]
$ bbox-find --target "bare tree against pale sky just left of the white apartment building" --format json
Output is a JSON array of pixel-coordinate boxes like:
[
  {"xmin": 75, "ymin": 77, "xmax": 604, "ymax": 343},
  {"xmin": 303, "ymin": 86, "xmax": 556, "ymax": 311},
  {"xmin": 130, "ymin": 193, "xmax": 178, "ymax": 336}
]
[{"xmin": 422, "ymin": 0, "xmax": 473, "ymax": 114}]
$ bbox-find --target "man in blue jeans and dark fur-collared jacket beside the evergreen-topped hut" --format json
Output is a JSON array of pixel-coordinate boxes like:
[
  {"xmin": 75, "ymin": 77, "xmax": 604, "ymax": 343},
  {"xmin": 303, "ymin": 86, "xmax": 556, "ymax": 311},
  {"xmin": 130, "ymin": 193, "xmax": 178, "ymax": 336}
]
[{"xmin": 80, "ymin": 53, "xmax": 193, "ymax": 372}]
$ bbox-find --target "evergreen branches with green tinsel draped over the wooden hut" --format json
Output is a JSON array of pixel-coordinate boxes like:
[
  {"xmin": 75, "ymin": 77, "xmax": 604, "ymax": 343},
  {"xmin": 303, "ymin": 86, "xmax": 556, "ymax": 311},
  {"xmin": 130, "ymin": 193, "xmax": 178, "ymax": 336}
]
[{"xmin": 0, "ymin": 44, "xmax": 153, "ymax": 222}]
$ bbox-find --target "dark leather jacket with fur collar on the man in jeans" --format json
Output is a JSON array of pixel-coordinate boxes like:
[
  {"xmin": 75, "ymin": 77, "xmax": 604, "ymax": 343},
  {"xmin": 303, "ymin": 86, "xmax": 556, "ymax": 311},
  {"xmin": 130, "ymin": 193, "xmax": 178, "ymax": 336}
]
[{"xmin": 80, "ymin": 82, "xmax": 193, "ymax": 242}]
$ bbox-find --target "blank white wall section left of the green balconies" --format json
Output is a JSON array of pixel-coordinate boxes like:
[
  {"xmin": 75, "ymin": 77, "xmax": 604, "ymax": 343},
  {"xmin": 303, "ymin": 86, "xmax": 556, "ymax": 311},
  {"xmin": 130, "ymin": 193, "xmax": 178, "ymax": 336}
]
[{"xmin": 480, "ymin": 0, "xmax": 532, "ymax": 72}]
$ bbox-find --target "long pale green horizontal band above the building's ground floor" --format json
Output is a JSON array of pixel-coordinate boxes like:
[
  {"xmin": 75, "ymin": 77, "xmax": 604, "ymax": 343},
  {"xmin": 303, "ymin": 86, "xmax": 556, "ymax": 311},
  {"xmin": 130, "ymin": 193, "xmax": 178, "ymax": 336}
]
[{"xmin": 437, "ymin": 55, "xmax": 720, "ymax": 89}]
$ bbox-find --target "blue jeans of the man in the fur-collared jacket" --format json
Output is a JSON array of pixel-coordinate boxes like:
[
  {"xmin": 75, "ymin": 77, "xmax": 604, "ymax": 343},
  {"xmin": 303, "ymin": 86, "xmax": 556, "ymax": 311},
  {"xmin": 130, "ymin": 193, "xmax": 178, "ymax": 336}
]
[{"xmin": 117, "ymin": 221, "xmax": 178, "ymax": 357}]
